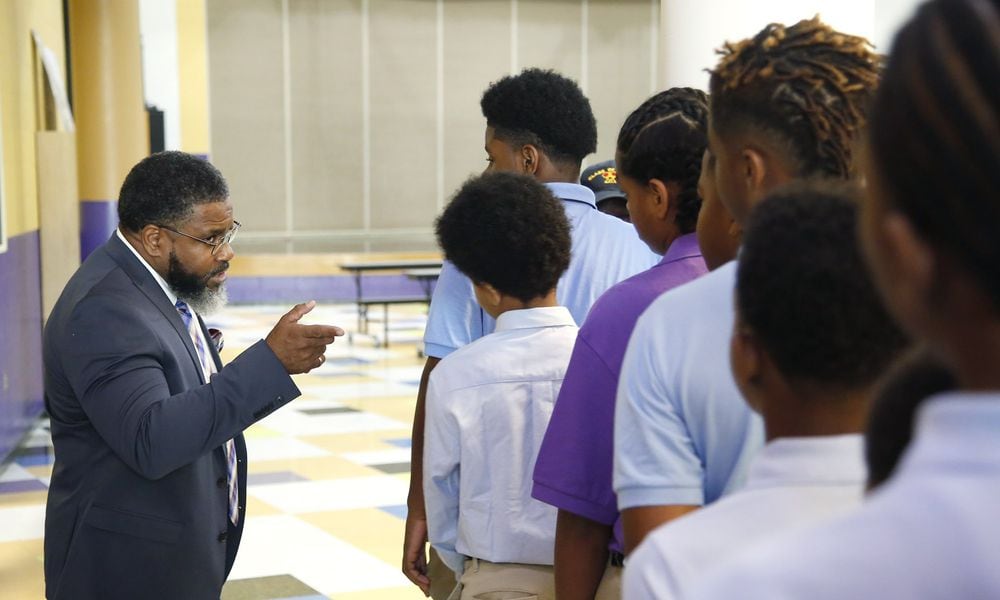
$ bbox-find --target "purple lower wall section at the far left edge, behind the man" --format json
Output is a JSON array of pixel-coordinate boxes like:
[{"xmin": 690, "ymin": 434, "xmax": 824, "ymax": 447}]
[{"xmin": 0, "ymin": 231, "xmax": 42, "ymax": 461}]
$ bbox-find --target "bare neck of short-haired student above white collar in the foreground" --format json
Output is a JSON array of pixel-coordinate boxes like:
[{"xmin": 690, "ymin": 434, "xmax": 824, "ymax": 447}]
[{"xmin": 761, "ymin": 388, "xmax": 870, "ymax": 442}]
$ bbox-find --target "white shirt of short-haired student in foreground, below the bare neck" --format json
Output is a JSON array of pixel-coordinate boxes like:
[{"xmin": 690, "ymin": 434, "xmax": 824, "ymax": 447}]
[{"xmin": 624, "ymin": 435, "xmax": 865, "ymax": 600}]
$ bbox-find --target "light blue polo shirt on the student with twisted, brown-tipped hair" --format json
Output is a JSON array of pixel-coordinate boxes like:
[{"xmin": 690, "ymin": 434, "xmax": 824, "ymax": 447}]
[{"xmin": 613, "ymin": 261, "xmax": 764, "ymax": 510}]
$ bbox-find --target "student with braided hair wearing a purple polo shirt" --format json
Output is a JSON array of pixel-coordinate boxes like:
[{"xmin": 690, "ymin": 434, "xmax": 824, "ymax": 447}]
[{"xmin": 532, "ymin": 88, "xmax": 708, "ymax": 600}]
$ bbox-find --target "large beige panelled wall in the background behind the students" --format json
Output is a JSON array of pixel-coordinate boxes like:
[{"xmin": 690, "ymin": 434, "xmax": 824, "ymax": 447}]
[{"xmin": 207, "ymin": 0, "xmax": 659, "ymax": 253}]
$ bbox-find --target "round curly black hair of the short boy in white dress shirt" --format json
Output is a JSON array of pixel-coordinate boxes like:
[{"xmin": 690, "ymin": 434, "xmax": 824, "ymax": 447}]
[{"xmin": 436, "ymin": 173, "xmax": 572, "ymax": 302}]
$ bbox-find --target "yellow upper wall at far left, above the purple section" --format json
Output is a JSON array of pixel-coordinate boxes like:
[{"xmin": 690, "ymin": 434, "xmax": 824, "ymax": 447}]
[{"xmin": 0, "ymin": 0, "xmax": 66, "ymax": 237}]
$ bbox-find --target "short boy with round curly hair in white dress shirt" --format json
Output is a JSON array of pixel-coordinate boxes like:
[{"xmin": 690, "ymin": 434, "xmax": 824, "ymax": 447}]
[{"xmin": 423, "ymin": 173, "xmax": 577, "ymax": 599}]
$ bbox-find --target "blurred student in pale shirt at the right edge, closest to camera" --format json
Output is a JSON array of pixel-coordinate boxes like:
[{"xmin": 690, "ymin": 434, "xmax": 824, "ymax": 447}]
[{"xmin": 693, "ymin": 0, "xmax": 1000, "ymax": 600}]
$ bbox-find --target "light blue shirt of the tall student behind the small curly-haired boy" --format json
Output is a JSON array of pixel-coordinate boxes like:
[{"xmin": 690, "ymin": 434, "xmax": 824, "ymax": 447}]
[{"xmin": 424, "ymin": 183, "xmax": 660, "ymax": 358}]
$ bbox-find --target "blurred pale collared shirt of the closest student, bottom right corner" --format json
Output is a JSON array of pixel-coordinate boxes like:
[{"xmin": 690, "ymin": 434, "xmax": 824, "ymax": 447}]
[{"xmin": 691, "ymin": 392, "xmax": 1000, "ymax": 600}]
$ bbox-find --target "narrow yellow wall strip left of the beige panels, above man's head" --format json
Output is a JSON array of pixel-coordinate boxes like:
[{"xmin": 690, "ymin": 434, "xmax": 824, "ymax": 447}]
[{"xmin": 177, "ymin": 0, "xmax": 211, "ymax": 154}]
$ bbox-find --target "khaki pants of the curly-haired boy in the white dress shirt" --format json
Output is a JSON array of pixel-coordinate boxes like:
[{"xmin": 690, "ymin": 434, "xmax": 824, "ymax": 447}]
[{"xmin": 452, "ymin": 558, "xmax": 556, "ymax": 600}]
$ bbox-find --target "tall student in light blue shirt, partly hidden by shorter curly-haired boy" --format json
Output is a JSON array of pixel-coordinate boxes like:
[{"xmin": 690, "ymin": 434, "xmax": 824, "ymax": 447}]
[{"xmin": 402, "ymin": 69, "xmax": 659, "ymax": 598}]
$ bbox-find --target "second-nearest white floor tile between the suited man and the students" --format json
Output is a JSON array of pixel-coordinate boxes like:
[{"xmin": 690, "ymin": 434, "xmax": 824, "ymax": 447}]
[{"xmin": 247, "ymin": 475, "xmax": 409, "ymax": 514}]
